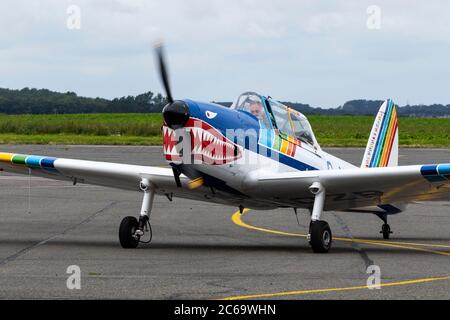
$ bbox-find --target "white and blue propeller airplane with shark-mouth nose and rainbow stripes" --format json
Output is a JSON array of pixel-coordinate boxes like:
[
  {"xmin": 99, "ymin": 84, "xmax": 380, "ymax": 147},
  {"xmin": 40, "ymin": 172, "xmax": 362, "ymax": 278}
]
[{"xmin": 0, "ymin": 45, "xmax": 450, "ymax": 253}]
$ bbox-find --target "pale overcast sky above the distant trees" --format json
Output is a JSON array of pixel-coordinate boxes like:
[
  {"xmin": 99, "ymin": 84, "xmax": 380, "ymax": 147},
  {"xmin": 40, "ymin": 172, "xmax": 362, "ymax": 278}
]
[{"xmin": 0, "ymin": 0, "xmax": 450, "ymax": 108}]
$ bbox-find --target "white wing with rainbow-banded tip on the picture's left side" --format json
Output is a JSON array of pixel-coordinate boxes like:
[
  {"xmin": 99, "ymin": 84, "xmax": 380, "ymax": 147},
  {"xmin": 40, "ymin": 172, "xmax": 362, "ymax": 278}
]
[{"xmin": 0, "ymin": 153, "xmax": 225, "ymax": 202}]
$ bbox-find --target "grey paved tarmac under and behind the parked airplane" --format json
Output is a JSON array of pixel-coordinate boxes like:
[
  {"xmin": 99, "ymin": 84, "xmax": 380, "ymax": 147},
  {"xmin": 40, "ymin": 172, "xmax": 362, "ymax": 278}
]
[{"xmin": 0, "ymin": 145, "xmax": 450, "ymax": 299}]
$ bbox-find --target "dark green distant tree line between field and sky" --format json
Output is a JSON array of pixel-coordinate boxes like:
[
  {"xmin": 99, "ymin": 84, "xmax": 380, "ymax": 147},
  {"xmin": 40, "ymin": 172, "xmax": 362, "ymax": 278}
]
[{"xmin": 0, "ymin": 88, "xmax": 450, "ymax": 118}]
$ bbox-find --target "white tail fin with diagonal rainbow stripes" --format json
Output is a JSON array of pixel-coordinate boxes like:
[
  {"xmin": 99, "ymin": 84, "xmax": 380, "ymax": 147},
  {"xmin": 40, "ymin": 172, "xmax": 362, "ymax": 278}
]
[{"xmin": 361, "ymin": 99, "xmax": 398, "ymax": 168}]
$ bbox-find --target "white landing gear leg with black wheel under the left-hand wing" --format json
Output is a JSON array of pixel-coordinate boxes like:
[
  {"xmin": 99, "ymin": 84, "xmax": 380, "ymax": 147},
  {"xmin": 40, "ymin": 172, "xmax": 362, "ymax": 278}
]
[{"xmin": 119, "ymin": 179, "xmax": 155, "ymax": 249}]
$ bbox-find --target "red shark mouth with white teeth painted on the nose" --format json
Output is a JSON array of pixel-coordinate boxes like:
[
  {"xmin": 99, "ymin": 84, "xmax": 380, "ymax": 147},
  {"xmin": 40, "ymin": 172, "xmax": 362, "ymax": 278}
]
[{"xmin": 163, "ymin": 118, "xmax": 242, "ymax": 165}]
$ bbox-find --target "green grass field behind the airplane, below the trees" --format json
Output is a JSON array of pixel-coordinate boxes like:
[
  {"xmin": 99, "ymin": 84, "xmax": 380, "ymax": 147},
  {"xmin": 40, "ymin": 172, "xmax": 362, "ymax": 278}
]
[{"xmin": 0, "ymin": 113, "xmax": 450, "ymax": 147}]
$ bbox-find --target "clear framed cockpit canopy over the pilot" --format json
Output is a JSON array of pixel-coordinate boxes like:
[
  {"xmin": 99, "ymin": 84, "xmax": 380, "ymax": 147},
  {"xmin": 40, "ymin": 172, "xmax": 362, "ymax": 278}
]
[{"xmin": 231, "ymin": 92, "xmax": 319, "ymax": 149}]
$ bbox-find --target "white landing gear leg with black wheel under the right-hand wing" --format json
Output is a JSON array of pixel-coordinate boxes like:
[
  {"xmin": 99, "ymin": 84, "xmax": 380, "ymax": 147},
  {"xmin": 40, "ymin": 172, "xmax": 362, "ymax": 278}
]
[{"xmin": 308, "ymin": 182, "xmax": 332, "ymax": 253}]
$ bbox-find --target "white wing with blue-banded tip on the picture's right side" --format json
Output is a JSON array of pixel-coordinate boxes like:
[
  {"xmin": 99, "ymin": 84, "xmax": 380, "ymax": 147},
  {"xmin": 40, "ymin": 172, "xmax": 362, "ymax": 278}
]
[{"xmin": 247, "ymin": 164, "xmax": 450, "ymax": 213}]
